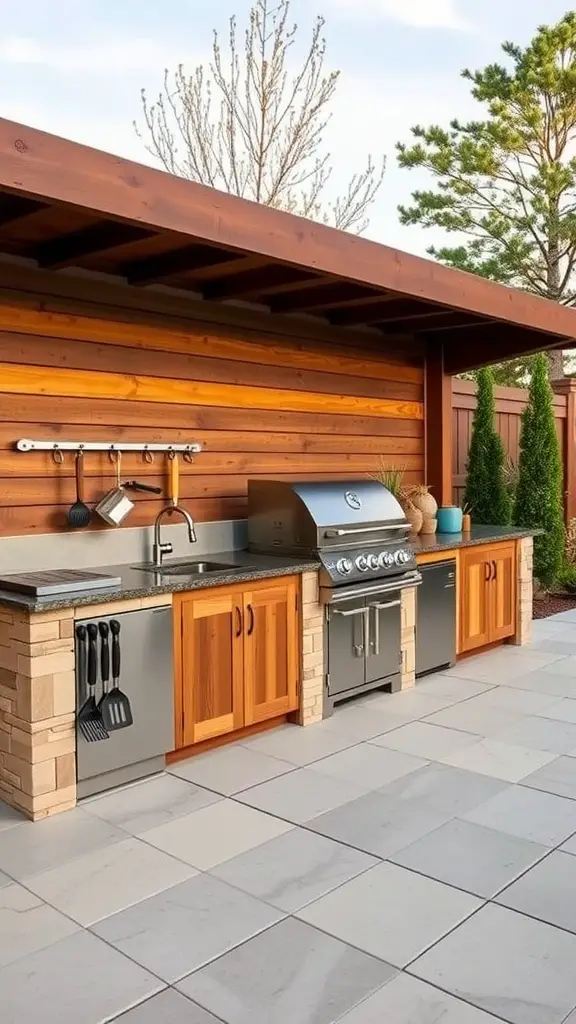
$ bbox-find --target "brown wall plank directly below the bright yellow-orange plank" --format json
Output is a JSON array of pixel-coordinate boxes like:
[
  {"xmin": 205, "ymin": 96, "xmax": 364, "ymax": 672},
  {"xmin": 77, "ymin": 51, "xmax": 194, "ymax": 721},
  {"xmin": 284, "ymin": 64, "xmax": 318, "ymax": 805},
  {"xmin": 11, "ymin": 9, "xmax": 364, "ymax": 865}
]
[{"xmin": 0, "ymin": 394, "xmax": 424, "ymax": 436}]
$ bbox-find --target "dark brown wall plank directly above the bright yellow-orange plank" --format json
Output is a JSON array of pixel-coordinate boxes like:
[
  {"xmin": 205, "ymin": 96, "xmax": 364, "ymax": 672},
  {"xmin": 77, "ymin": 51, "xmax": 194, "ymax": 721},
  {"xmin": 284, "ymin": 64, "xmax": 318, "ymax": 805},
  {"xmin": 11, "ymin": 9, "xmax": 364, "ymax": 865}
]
[{"xmin": 0, "ymin": 331, "xmax": 423, "ymax": 401}]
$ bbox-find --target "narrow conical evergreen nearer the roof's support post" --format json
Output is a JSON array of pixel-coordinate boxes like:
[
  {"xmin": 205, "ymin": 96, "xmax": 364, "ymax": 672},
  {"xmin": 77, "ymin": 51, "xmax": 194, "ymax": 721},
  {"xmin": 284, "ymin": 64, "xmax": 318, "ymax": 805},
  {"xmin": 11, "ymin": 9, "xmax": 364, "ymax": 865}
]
[{"xmin": 464, "ymin": 367, "xmax": 511, "ymax": 525}]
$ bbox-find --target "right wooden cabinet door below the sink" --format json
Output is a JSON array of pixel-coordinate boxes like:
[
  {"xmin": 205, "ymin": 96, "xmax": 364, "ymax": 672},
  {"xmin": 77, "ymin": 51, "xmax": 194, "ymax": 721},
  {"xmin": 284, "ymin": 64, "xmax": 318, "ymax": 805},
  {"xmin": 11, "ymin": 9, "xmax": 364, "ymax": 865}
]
[{"xmin": 243, "ymin": 577, "xmax": 299, "ymax": 725}]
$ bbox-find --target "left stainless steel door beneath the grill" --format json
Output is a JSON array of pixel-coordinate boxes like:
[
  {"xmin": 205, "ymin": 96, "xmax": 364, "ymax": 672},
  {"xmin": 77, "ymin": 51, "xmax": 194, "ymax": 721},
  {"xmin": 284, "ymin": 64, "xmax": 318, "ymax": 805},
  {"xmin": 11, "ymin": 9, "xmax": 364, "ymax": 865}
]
[{"xmin": 328, "ymin": 597, "xmax": 368, "ymax": 696}]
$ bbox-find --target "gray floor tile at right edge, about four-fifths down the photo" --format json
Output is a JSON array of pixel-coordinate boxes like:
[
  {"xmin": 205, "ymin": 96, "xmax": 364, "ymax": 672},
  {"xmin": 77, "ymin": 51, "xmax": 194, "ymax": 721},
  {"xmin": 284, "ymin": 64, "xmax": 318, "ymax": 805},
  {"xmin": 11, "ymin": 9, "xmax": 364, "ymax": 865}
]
[{"xmin": 463, "ymin": 785, "xmax": 576, "ymax": 847}]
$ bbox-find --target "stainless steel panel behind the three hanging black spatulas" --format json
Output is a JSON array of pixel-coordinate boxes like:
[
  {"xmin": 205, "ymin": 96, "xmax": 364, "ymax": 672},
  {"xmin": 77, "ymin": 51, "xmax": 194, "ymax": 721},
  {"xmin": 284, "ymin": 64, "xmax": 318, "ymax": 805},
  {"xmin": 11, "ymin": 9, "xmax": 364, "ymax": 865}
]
[{"xmin": 76, "ymin": 608, "xmax": 174, "ymax": 780}]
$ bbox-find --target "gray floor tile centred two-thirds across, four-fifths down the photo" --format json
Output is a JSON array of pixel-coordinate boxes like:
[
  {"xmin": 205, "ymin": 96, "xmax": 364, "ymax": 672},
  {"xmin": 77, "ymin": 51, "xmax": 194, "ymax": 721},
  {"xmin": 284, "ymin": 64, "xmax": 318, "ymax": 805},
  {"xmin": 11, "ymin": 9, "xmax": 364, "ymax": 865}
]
[{"xmin": 307, "ymin": 791, "xmax": 449, "ymax": 858}]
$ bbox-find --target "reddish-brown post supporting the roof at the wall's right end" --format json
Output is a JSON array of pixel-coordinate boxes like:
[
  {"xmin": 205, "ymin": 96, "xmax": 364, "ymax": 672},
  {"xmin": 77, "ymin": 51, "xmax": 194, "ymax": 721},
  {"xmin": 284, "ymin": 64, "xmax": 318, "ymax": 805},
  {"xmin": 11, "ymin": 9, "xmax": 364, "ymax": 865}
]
[{"xmin": 424, "ymin": 341, "xmax": 453, "ymax": 505}]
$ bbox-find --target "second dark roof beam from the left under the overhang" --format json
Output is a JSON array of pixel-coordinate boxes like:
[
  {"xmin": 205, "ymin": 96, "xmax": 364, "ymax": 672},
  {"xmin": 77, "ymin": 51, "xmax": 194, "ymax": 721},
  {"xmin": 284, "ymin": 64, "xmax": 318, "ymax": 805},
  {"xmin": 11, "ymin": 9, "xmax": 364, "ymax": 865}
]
[{"xmin": 27, "ymin": 220, "xmax": 156, "ymax": 270}]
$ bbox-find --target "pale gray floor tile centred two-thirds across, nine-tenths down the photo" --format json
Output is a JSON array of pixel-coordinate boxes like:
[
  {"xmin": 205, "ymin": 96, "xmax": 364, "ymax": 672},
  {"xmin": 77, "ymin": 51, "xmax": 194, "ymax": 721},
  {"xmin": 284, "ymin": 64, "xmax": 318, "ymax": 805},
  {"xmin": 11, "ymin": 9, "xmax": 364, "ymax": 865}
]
[{"xmin": 297, "ymin": 863, "xmax": 482, "ymax": 967}]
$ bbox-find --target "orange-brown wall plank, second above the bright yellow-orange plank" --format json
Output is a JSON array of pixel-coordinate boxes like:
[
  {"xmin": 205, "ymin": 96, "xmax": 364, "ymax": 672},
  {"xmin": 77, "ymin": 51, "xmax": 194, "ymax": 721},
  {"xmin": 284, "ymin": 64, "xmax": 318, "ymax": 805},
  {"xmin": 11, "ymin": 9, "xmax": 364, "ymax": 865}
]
[{"xmin": 0, "ymin": 305, "xmax": 423, "ymax": 385}]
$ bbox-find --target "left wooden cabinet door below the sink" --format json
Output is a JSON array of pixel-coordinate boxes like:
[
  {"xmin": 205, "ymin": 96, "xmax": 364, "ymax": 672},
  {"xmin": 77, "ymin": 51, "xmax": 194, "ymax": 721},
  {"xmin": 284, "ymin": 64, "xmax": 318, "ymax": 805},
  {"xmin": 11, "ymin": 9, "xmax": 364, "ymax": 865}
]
[{"xmin": 180, "ymin": 589, "xmax": 244, "ymax": 746}]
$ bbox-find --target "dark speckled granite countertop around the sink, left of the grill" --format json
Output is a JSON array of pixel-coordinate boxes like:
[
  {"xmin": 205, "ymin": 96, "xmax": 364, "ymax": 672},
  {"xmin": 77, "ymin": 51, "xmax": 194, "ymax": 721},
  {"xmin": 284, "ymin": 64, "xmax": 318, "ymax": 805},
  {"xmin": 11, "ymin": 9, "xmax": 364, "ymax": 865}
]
[{"xmin": 0, "ymin": 551, "xmax": 320, "ymax": 611}]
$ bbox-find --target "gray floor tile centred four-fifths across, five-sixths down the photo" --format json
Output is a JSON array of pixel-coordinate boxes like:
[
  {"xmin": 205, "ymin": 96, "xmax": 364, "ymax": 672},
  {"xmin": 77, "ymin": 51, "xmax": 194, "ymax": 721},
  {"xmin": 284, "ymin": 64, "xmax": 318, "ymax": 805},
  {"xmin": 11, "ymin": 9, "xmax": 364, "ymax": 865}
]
[{"xmin": 390, "ymin": 818, "xmax": 545, "ymax": 899}]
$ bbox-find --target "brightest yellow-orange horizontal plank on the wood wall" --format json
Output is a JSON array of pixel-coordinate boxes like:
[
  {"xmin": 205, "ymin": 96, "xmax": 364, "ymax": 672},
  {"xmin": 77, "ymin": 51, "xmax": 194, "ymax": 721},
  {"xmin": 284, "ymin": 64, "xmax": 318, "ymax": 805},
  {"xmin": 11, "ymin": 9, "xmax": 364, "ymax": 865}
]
[{"xmin": 0, "ymin": 362, "xmax": 423, "ymax": 420}]
